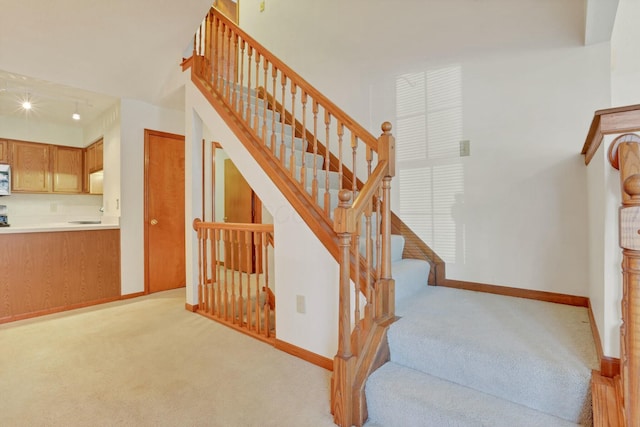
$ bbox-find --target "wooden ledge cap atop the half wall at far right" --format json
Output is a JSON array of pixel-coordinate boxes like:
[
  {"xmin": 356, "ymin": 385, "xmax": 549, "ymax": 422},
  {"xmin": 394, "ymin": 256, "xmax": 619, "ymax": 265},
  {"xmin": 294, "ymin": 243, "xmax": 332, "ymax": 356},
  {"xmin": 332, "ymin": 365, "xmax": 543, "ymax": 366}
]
[{"xmin": 581, "ymin": 104, "xmax": 640, "ymax": 165}]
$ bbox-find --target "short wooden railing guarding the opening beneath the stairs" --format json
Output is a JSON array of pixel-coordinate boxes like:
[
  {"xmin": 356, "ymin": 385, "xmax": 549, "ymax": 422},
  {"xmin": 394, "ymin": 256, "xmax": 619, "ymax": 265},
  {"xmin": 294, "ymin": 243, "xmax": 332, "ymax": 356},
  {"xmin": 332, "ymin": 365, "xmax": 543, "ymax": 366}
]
[{"xmin": 193, "ymin": 219, "xmax": 275, "ymax": 341}]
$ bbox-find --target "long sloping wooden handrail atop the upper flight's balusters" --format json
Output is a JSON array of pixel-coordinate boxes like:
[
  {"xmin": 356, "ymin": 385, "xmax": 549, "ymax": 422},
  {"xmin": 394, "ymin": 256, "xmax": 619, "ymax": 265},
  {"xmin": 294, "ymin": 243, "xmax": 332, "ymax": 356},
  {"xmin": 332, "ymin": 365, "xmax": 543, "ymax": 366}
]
[{"xmin": 205, "ymin": 8, "xmax": 378, "ymax": 151}]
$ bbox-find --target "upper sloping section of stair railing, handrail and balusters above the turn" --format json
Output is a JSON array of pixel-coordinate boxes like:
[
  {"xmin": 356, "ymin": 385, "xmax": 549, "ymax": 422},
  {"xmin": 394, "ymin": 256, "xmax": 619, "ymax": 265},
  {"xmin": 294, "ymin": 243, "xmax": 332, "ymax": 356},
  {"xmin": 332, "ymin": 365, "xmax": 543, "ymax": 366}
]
[{"xmin": 193, "ymin": 8, "xmax": 378, "ymax": 223}]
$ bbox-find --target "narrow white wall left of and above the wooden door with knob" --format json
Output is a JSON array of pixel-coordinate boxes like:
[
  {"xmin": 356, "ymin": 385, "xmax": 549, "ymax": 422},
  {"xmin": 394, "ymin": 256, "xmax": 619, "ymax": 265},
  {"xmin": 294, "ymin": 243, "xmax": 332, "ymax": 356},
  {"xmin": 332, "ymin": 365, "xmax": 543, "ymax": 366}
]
[{"xmin": 119, "ymin": 99, "xmax": 185, "ymax": 295}]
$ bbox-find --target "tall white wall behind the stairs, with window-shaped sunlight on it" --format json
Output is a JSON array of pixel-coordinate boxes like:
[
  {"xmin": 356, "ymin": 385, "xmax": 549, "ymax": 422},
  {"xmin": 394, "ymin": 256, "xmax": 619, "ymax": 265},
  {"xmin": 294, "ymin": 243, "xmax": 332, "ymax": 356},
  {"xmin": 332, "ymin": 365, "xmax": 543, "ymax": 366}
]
[{"xmin": 240, "ymin": 0, "xmax": 610, "ymax": 296}]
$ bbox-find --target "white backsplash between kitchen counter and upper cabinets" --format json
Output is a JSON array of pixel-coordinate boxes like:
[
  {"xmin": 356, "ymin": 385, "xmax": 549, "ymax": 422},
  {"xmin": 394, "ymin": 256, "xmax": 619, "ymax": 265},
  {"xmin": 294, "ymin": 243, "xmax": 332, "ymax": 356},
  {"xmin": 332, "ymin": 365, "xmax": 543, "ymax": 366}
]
[{"xmin": 0, "ymin": 193, "xmax": 102, "ymax": 226}]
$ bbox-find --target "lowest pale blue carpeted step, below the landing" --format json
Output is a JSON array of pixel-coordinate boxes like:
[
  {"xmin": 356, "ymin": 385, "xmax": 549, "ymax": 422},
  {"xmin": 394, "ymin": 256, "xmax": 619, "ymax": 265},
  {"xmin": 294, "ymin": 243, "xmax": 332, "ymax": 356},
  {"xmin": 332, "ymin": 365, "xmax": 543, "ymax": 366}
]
[{"xmin": 365, "ymin": 362, "xmax": 577, "ymax": 427}]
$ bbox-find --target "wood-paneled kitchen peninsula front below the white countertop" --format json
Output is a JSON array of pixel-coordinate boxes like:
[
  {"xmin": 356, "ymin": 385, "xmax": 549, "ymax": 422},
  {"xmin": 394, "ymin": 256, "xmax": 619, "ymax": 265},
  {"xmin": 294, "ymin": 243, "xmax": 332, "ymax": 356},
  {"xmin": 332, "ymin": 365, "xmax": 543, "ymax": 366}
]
[{"xmin": 0, "ymin": 229, "xmax": 120, "ymax": 323}]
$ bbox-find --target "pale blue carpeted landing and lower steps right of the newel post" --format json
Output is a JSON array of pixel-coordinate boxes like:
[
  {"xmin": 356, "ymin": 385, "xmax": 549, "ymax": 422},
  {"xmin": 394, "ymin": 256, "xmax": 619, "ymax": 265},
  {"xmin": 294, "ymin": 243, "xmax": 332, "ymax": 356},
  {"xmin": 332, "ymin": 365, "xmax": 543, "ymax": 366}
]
[{"xmin": 366, "ymin": 260, "xmax": 599, "ymax": 427}]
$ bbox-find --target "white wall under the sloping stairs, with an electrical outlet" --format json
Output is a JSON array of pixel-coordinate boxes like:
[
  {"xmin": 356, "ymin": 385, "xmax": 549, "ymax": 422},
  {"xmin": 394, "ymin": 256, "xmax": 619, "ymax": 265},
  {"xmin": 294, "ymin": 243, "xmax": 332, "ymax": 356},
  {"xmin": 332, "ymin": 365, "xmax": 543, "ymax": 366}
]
[{"xmin": 186, "ymin": 84, "xmax": 339, "ymax": 358}]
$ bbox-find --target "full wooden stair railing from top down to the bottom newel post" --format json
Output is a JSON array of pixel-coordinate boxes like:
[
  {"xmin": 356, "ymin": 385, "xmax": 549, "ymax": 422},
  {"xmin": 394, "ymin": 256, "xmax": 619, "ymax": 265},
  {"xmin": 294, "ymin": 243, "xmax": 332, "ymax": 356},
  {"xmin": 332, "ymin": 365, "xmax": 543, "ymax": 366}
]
[{"xmin": 192, "ymin": 8, "xmax": 395, "ymax": 426}]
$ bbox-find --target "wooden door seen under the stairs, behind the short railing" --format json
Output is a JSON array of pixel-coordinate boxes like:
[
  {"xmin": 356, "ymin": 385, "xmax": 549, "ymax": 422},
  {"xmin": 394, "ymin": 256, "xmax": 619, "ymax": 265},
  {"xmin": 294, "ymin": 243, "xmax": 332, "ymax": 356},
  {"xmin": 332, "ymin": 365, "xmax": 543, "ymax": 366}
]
[{"xmin": 224, "ymin": 159, "xmax": 262, "ymax": 273}]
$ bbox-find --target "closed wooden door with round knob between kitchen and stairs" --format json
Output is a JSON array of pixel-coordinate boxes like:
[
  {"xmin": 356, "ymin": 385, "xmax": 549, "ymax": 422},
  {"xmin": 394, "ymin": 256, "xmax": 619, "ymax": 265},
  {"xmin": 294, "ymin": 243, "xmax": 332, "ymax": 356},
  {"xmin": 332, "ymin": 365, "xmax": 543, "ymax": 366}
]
[{"xmin": 144, "ymin": 129, "xmax": 186, "ymax": 293}]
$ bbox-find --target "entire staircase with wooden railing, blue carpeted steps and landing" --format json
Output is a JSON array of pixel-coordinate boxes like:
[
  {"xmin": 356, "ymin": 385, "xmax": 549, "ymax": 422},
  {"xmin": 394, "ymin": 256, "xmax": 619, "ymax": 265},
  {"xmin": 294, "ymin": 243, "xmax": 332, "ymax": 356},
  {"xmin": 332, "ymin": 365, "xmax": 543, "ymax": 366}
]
[{"xmin": 186, "ymin": 10, "xmax": 598, "ymax": 427}]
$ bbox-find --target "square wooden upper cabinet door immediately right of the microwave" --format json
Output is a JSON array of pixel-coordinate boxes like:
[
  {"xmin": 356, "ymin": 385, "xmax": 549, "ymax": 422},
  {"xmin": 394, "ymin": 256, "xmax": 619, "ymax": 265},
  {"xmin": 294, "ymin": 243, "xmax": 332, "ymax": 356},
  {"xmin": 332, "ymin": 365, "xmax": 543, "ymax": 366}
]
[{"xmin": 9, "ymin": 141, "xmax": 51, "ymax": 193}]
